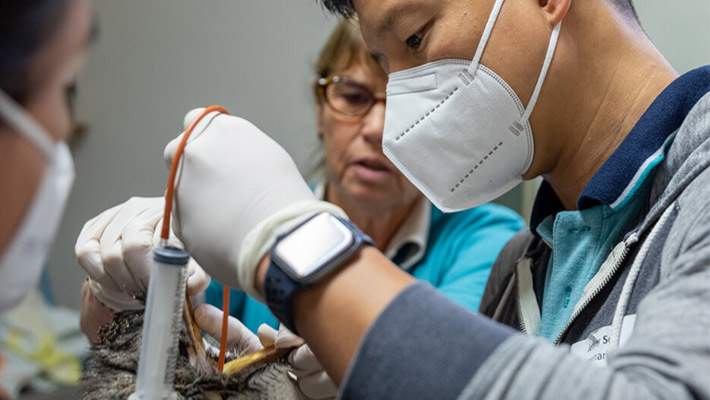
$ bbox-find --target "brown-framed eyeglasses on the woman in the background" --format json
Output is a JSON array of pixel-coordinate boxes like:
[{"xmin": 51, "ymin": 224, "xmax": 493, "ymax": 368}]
[{"xmin": 316, "ymin": 76, "xmax": 385, "ymax": 117}]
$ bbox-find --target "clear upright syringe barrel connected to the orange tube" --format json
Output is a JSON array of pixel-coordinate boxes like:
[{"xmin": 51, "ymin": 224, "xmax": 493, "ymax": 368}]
[{"xmin": 129, "ymin": 247, "xmax": 190, "ymax": 400}]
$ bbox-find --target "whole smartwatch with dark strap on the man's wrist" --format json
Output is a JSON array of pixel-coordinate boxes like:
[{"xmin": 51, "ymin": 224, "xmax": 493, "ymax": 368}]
[{"xmin": 264, "ymin": 212, "xmax": 375, "ymax": 334}]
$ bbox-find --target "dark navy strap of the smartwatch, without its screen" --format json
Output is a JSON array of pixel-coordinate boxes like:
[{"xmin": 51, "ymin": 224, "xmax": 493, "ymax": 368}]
[{"xmin": 264, "ymin": 214, "xmax": 375, "ymax": 335}]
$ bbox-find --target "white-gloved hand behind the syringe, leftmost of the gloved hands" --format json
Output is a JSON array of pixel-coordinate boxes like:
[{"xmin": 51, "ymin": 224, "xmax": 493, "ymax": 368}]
[{"xmin": 74, "ymin": 197, "xmax": 210, "ymax": 310}]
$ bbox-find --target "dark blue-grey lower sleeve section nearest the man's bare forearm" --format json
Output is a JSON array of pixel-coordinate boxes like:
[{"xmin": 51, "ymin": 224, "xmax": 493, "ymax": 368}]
[{"xmin": 341, "ymin": 283, "xmax": 516, "ymax": 400}]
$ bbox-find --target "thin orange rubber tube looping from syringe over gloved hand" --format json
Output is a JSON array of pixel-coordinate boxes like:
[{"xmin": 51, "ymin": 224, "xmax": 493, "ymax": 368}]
[{"xmin": 160, "ymin": 106, "xmax": 229, "ymax": 372}]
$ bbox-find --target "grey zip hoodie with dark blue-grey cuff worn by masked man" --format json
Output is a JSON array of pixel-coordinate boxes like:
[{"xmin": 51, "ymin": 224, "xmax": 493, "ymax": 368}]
[{"xmin": 341, "ymin": 67, "xmax": 710, "ymax": 400}]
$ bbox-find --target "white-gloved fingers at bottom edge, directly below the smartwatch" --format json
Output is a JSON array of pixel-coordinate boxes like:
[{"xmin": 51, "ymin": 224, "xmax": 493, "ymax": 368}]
[{"xmin": 259, "ymin": 324, "xmax": 338, "ymax": 399}]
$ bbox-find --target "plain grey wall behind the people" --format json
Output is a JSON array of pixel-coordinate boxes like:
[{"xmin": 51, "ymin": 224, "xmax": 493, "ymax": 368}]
[{"xmin": 49, "ymin": 0, "xmax": 710, "ymax": 307}]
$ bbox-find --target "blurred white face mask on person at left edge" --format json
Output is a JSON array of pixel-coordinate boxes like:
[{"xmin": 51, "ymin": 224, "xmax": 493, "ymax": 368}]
[{"xmin": 0, "ymin": 90, "xmax": 74, "ymax": 311}]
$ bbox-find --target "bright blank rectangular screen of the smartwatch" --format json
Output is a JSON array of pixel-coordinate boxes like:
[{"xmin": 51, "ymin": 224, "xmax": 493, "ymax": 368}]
[{"xmin": 274, "ymin": 213, "xmax": 355, "ymax": 278}]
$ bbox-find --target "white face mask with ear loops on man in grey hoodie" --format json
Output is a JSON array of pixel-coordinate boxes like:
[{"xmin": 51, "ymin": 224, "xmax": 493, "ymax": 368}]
[{"xmin": 382, "ymin": 0, "xmax": 560, "ymax": 212}]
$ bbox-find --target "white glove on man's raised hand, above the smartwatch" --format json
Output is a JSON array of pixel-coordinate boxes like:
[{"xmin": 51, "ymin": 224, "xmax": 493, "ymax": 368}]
[{"xmin": 164, "ymin": 109, "xmax": 345, "ymax": 302}]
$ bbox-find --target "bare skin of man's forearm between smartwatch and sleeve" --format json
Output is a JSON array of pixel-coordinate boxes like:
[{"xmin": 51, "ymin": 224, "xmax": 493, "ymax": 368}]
[{"xmin": 256, "ymin": 247, "xmax": 415, "ymax": 383}]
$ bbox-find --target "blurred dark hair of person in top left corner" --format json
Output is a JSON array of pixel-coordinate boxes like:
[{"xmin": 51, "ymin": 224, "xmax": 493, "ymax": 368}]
[{"xmin": 0, "ymin": 0, "xmax": 71, "ymax": 104}]
